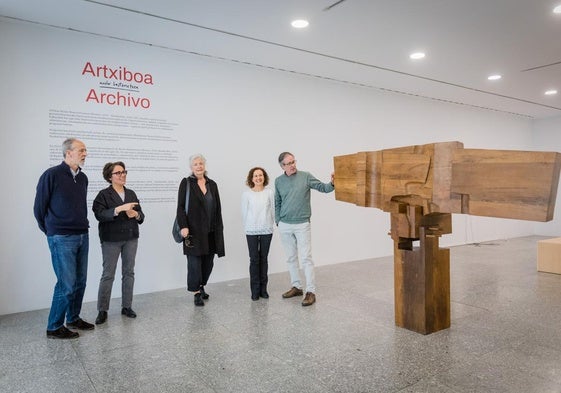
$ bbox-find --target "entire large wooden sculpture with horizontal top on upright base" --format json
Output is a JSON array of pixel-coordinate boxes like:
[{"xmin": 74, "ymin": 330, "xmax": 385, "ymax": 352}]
[{"xmin": 334, "ymin": 142, "xmax": 561, "ymax": 334}]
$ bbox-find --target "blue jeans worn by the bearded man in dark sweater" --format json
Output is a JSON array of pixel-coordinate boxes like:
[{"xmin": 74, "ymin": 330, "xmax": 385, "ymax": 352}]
[{"xmin": 47, "ymin": 233, "xmax": 89, "ymax": 330}]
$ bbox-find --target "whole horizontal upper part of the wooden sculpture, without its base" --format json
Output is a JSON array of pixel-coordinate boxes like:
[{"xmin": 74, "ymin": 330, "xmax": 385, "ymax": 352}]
[{"xmin": 334, "ymin": 142, "xmax": 561, "ymax": 221}]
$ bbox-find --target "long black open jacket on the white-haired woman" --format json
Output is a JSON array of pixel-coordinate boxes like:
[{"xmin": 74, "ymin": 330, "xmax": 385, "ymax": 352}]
[{"xmin": 176, "ymin": 175, "xmax": 225, "ymax": 257}]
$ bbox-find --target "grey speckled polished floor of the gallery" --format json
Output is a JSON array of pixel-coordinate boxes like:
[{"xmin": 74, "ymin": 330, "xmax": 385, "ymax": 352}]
[{"xmin": 0, "ymin": 237, "xmax": 561, "ymax": 393}]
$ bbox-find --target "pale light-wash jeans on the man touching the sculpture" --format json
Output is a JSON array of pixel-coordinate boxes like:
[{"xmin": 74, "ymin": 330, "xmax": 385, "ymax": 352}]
[{"xmin": 278, "ymin": 221, "xmax": 316, "ymax": 293}]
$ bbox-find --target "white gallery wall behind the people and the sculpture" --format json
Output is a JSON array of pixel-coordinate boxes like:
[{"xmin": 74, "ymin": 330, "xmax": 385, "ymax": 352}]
[{"xmin": 0, "ymin": 18, "xmax": 544, "ymax": 319}]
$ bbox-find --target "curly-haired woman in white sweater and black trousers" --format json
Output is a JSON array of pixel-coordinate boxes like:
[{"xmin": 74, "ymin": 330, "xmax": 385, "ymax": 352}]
[{"xmin": 242, "ymin": 167, "xmax": 275, "ymax": 300}]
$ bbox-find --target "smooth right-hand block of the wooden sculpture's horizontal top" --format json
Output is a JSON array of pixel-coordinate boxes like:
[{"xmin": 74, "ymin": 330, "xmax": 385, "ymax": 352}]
[{"xmin": 450, "ymin": 149, "xmax": 561, "ymax": 221}]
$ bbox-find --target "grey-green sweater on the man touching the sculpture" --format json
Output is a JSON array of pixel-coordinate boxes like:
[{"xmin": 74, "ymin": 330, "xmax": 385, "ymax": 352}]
[{"xmin": 275, "ymin": 171, "xmax": 335, "ymax": 225}]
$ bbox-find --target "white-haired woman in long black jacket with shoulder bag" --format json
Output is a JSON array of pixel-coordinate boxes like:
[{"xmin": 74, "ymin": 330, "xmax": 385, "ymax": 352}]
[{"xmin": 176, "ymin": 154, "xmax": 225, "ymax": 306}]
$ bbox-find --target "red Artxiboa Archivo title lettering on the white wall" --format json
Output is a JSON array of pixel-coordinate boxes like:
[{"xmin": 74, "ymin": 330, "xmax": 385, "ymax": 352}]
[{"xmin": 82, "ymin": 61, "xmax": 154, "ymax": 109}]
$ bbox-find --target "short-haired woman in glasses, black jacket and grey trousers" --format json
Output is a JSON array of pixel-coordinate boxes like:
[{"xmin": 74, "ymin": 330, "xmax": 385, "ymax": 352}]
[{"xmin": 92, "ymin": 161, "xmax": 144, "ymax": 325}]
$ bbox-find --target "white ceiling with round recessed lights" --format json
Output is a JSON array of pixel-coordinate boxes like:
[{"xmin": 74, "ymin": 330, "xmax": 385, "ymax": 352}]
[{"xmin": 0, "ymin": 0, "xmax": 561, "ymax": 118}]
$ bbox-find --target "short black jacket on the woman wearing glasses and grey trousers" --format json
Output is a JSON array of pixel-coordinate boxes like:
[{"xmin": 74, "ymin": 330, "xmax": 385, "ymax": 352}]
[{"xmin": 92, "ymin": 186, "xmax": 144, "ymax": 243}]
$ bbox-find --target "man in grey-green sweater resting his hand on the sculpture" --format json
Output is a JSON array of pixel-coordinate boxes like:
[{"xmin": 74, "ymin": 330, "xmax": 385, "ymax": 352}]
[{"xmin": 275, "ymin": 152, "xmax": 335, "ymax": 306}]
